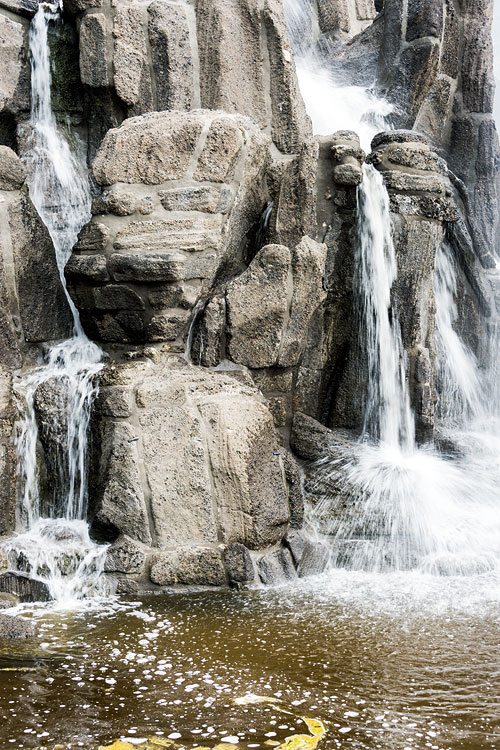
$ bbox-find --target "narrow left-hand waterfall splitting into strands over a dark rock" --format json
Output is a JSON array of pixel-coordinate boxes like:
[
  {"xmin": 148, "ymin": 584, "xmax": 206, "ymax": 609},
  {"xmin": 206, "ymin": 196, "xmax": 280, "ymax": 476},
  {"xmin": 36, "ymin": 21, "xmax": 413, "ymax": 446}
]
[{"xmin": 4, "ymin": 1, "xmax": 106, "ymax": 603}]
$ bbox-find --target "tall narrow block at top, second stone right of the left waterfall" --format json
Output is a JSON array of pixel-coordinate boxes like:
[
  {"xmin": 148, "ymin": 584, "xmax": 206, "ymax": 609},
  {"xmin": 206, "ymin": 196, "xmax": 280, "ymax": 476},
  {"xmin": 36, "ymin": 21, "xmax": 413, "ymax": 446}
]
[{"xmin": 113, "ymin": 5, "xmax": 153, "ymax": 114}]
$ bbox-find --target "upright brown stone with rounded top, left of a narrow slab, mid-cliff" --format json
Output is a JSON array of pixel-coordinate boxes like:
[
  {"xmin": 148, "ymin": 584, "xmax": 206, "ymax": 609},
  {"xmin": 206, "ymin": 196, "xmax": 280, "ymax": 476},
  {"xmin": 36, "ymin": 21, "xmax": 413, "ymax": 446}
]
[{"xmin": 226, "ymin": 245, "xmax": 291, "ymax": 368}]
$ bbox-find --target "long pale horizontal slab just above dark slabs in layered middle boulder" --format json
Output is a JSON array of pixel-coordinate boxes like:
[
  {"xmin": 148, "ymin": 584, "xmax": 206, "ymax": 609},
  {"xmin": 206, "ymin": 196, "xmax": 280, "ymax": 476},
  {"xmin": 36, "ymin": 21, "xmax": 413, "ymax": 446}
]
[{"xmin": 114, "ymin": 213, "xmax": 222, "ymax": 253}]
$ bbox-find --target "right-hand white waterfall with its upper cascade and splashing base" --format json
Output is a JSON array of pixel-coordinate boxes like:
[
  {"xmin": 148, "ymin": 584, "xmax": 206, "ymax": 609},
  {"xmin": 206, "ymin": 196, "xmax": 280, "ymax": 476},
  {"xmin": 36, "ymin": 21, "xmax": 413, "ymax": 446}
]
[{"xmin": 284, "ymin": 0, "xmax": 500, "ymax": 575}]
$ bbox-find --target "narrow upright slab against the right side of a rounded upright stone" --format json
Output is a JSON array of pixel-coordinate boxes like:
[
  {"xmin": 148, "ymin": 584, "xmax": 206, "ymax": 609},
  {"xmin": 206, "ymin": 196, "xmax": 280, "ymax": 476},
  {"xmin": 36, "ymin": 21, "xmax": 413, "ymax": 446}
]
[{"xmin": 278, "ymin": 237, "xmax": 326, "ymax": 367}]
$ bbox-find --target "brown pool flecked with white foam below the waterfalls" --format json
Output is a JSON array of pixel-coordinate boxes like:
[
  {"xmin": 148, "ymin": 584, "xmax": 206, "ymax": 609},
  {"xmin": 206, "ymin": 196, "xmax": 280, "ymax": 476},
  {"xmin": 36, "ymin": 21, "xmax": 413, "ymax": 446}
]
[{"xmin": 0, "ymin": 572, "xmax": 500, "ymax": 750}]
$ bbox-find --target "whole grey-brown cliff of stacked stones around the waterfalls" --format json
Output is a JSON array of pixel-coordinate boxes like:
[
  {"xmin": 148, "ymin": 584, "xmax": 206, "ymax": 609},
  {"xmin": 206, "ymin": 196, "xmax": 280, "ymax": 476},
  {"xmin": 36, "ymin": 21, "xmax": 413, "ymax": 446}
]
[{"xmin": 0, "ymin": 0, "xmax": 500, "ymax": 592}]
